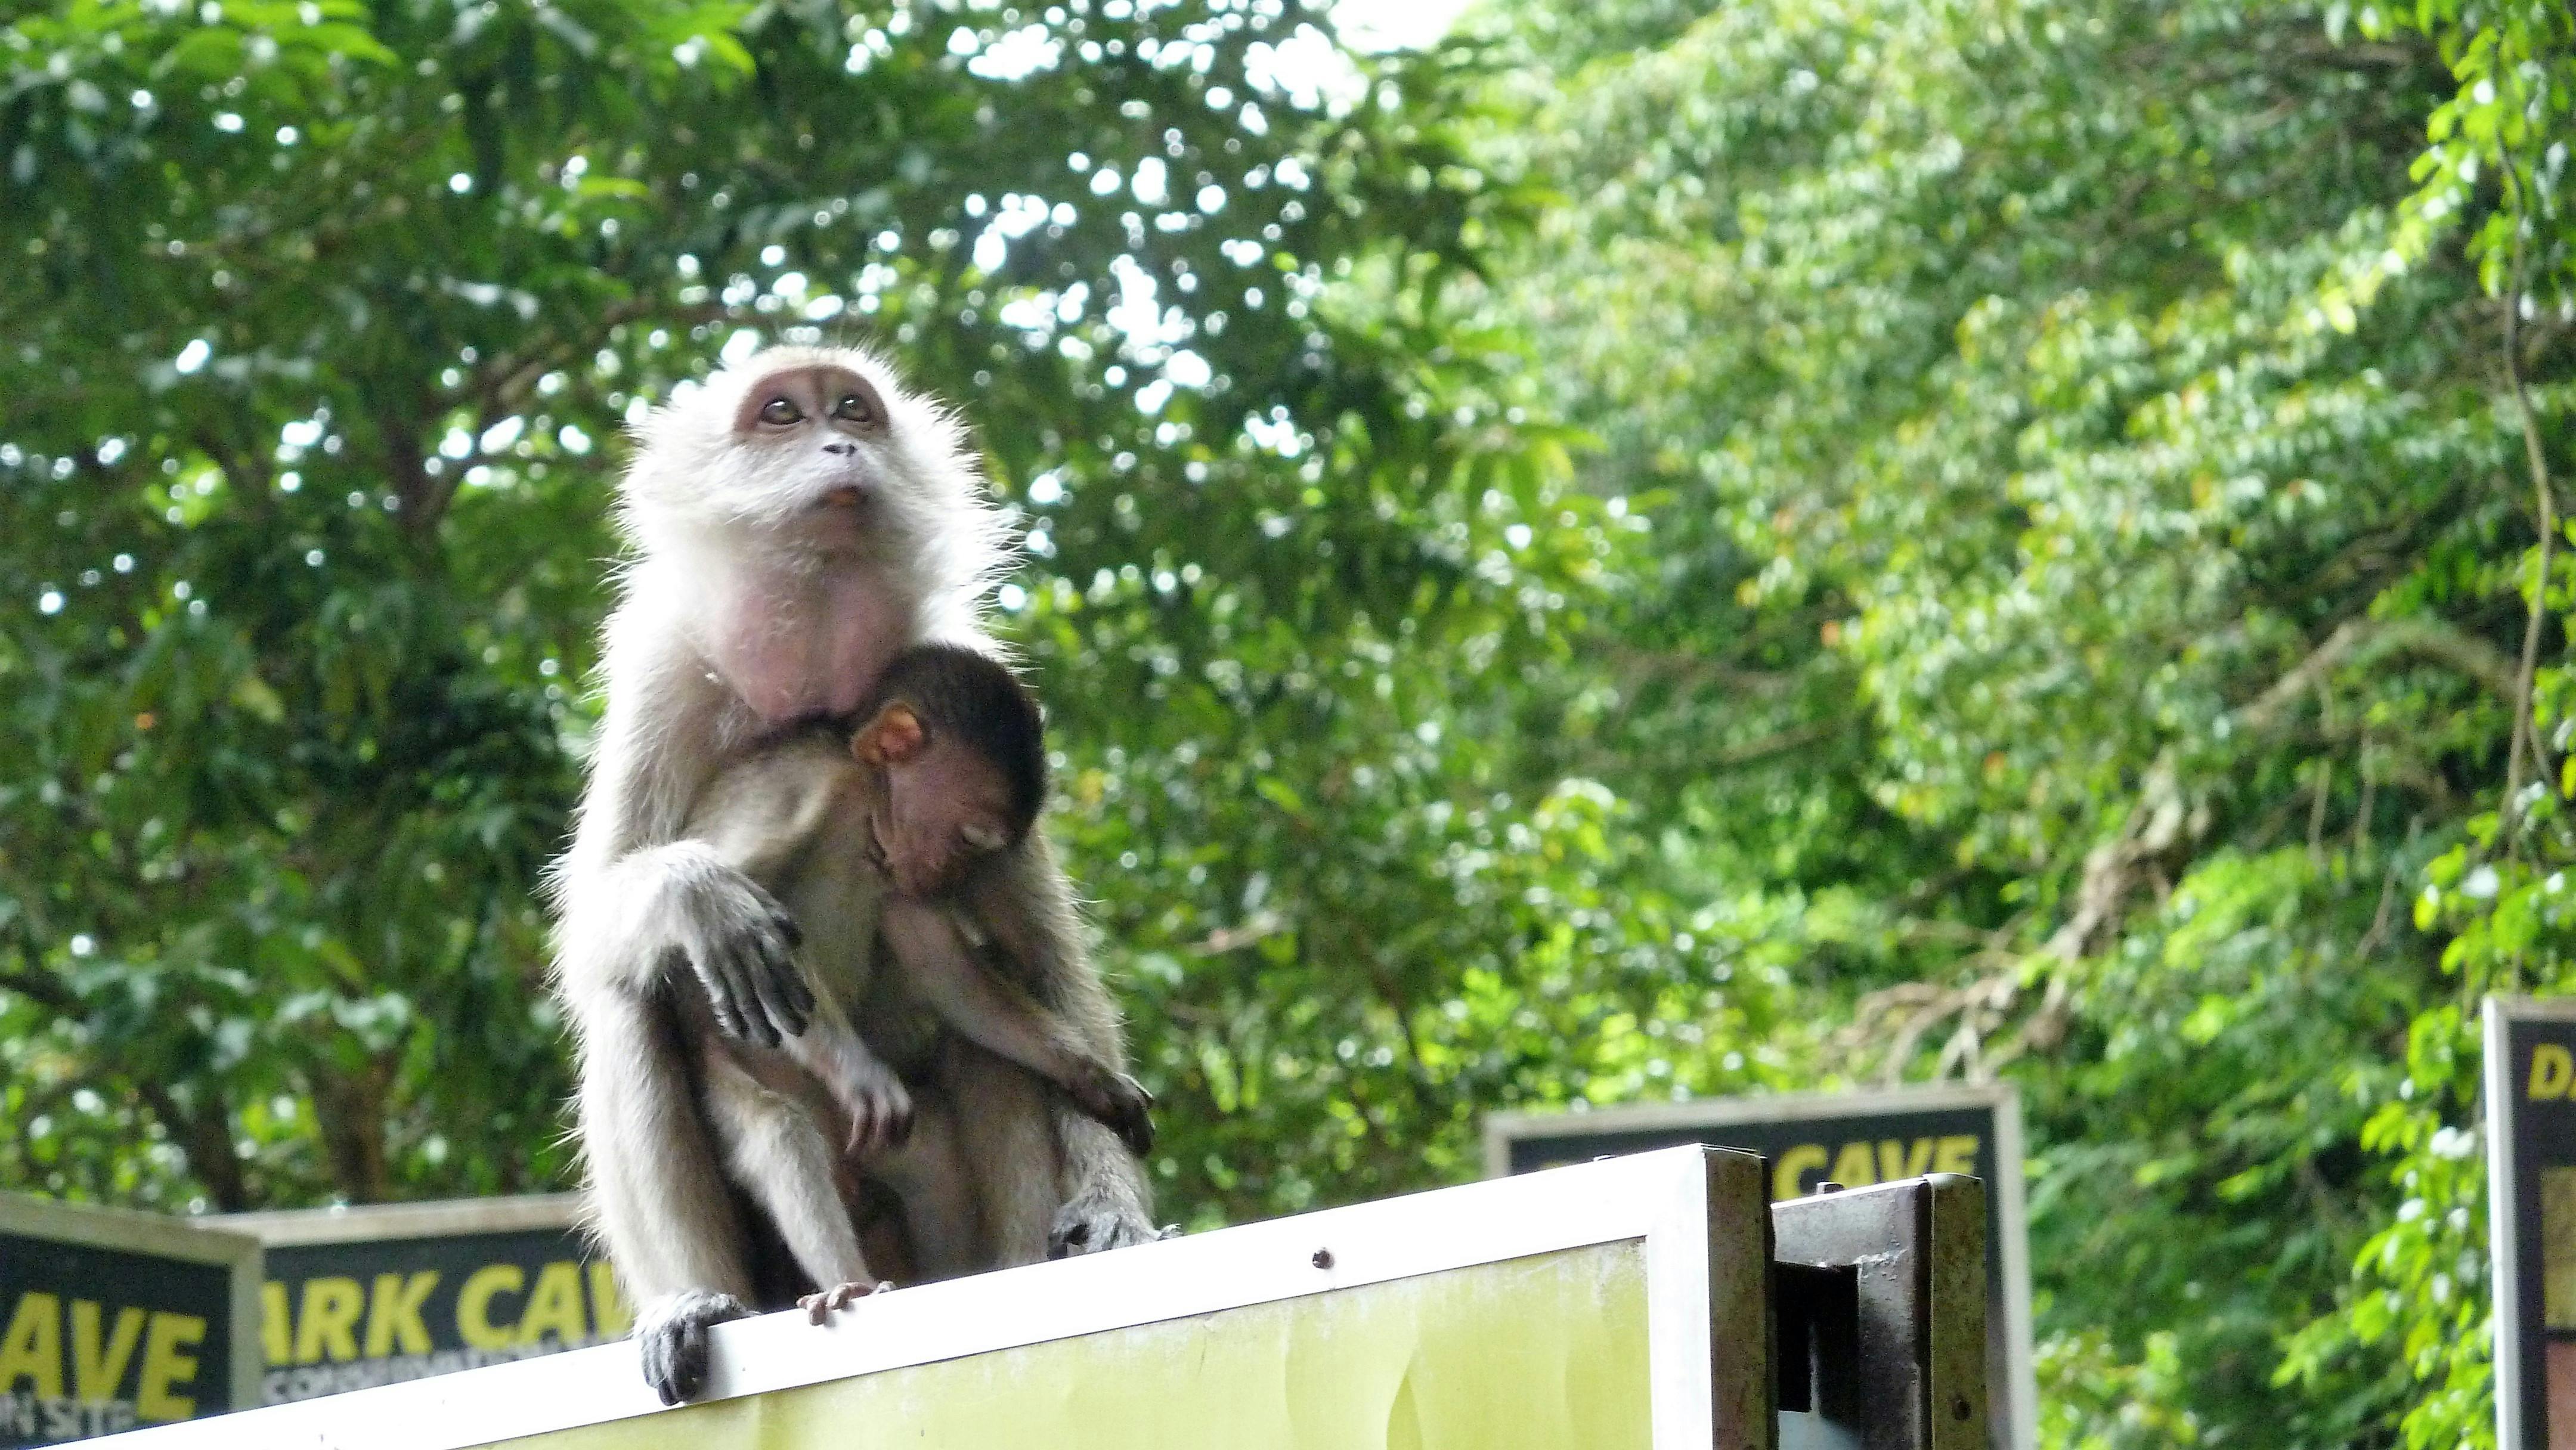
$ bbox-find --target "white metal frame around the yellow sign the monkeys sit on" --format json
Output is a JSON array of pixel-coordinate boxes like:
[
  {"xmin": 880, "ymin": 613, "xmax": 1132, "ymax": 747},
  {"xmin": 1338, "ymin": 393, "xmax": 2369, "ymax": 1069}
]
[{"xmin": 93, "ymin": 1149, "xmax": 1772, "ymax": 1450}]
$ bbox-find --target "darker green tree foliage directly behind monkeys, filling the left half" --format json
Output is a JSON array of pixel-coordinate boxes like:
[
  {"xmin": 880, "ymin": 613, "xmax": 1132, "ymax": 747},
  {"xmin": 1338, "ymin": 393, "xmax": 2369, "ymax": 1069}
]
[{"xmin": 0, "ymin": 0, "xmax": 1698, "ymax": 1218}]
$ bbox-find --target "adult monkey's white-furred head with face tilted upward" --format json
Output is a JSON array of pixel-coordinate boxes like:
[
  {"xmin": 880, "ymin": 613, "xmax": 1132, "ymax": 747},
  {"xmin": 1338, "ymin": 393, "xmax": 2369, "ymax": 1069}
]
[{"xmin": 626, "ymin": 348, "xmax": 979, "ymax": 554}]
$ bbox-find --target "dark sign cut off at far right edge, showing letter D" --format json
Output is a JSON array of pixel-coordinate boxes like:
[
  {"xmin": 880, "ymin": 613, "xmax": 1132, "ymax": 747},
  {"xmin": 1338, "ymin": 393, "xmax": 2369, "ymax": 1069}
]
[{"xmin": 2486, "ymin": 997, "xmax": 2576, "ymax": 1450}]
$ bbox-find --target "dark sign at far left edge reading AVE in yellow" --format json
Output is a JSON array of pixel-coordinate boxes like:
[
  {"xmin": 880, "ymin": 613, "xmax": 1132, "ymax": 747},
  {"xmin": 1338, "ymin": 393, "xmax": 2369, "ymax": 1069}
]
[{"xmin": 0, "ymin": 1195, "xmax": 260, "ymax": 1450}]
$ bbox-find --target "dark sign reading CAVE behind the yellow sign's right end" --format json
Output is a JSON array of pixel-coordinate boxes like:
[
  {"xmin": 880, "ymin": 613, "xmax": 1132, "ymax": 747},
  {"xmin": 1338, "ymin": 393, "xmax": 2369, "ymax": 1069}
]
[{"xmin": 1484, "ymin": 1085, "xmax": 2038, "ymax": 1450}]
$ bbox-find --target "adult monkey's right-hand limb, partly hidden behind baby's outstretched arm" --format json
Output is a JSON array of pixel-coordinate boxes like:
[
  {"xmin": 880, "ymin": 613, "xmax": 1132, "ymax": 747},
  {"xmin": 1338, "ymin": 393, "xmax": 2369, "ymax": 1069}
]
[{"xmin": 961, "ymin": 829, "xmax": 1159, "ymax": 1257}]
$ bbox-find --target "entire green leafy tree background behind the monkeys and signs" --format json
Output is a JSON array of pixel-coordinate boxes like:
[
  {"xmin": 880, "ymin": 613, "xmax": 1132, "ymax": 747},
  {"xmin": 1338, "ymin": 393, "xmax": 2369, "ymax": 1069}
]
[{"xmin": 0, "ymin": 0, "xmax": 2576, "ymax": 1445}]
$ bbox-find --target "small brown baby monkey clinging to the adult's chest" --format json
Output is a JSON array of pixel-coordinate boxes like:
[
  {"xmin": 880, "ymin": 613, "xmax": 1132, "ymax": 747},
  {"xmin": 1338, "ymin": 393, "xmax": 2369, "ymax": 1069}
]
[{"xmin": 675, "ymin": 646, "xmax": 1151, "ymax": 1313}]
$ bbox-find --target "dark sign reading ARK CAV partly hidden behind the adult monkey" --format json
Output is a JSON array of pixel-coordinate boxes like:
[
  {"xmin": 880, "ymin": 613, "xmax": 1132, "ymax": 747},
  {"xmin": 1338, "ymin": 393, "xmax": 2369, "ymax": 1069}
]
[{"xmin": 227, "ymin": 1195, "xmax": 628, "ymax": 1403}]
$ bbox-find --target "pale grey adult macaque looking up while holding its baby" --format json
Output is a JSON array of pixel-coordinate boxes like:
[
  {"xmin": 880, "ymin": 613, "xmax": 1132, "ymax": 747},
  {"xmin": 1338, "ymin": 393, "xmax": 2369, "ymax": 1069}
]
[{"xmin": 551, "ymin": 348, "xmax": 1154, "ymax": 1401}]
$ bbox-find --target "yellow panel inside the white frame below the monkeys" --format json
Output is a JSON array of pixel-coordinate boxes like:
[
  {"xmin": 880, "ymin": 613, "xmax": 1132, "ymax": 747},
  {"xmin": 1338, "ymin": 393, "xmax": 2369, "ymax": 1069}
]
[{"xmin": 505, "ymin": 1239, "xmax": 1651, "ymax": 1450}]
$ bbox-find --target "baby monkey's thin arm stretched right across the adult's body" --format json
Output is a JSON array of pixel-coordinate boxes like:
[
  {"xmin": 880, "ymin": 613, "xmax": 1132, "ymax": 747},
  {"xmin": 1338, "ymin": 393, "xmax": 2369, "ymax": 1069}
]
[{"xmin": 881, "ymin": 896, "xmax": 1154, "ymax": 1154}]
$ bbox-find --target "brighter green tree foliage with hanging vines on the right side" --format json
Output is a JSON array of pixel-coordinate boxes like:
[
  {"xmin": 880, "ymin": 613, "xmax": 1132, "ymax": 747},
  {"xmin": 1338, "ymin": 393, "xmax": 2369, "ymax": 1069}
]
[{"xmin": 1494, "ymin": 0, "xmax": 2571, "ymax": 1445}]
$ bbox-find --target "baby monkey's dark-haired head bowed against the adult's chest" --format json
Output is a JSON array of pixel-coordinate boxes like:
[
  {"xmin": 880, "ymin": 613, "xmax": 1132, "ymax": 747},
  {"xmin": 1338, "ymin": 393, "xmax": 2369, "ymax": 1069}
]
[{"xmin": 850, "ymin": 644, "xmax": 1046, "ymax": 896}]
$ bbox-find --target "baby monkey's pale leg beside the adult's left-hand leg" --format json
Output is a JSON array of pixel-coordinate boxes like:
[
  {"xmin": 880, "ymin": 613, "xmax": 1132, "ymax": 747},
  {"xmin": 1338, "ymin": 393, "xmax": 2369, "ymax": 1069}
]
[{"xmin": 706, "ymin": 1051, "xmax": 876, "ymax": 1290}]
